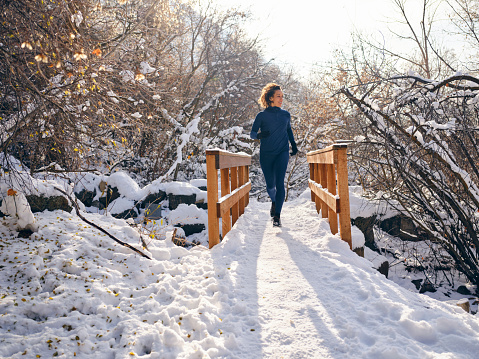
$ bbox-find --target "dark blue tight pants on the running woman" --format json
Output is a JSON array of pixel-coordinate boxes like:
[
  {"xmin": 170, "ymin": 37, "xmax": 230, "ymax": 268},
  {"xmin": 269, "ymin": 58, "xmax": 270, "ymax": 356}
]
[{"xmin": 259, "ymin": 151, "xmax": 289, "ymax": 215}]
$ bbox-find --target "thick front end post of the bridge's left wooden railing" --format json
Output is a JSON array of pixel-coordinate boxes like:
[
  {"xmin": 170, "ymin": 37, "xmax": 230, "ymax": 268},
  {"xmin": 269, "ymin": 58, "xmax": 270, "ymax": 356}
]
[{"xmin": 206, "ymin": 155, "xmax": 220, "ymax": 249}]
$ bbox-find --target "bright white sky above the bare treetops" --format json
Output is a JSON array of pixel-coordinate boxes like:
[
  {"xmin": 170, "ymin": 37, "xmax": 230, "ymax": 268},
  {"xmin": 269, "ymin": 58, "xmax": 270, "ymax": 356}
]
[{"xmin": 216, "ymin": 0, "xmax": 458, "ymax": 75}]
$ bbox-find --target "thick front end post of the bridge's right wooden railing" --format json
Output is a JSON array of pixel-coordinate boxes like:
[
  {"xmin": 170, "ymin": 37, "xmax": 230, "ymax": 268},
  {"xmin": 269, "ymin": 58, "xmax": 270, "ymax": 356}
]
[{"xmin": 337, "ymin": 147, "xmax": 353, "ymax": 249}]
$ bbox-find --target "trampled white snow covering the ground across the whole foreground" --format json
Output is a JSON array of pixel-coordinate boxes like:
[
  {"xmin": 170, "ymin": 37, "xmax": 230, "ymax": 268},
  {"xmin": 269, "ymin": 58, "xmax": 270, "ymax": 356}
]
[{"xmin": 0, "ymin": 190, "xmax": 479, "ymax": 359}]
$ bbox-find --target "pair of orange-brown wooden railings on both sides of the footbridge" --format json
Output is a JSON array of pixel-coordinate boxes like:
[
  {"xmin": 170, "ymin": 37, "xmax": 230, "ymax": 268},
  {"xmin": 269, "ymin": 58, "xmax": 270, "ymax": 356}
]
[{"xmin": 206, "ymin": 144, "xmax": 352, "ymax": 253}]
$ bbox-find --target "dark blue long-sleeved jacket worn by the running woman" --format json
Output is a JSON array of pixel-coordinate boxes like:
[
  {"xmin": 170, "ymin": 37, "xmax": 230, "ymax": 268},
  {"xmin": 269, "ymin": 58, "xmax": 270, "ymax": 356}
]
[{"xmin": 250, "ymin": 106, "xmax": 295, "ymax": 155}]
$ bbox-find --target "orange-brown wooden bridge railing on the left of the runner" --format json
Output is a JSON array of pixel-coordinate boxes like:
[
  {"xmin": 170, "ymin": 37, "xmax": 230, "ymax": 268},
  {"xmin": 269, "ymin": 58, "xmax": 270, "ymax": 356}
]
[{"xmin": 206, "ymin": 150, "xmax": 251, "ymax": 248}]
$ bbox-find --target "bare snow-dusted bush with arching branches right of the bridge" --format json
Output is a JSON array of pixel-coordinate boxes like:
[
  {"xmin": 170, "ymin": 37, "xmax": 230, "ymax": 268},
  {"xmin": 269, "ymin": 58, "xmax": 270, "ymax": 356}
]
[{"xmin": 341, "ymin": 73, "xmax": 479, "ymax": 292}]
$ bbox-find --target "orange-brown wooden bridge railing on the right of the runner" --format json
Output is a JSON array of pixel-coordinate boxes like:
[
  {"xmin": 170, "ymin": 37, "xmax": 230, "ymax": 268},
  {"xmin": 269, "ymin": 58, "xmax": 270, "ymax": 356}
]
[{"xmin": 306, "ymin": 144, "xmax": 352, "ymax": 249}]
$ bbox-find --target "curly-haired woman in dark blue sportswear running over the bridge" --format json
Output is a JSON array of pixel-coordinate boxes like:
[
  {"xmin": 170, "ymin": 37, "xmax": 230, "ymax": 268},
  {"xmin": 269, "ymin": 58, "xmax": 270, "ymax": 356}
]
[{"xmin": 250, "ymin": 83, "xmax": 298, "ymax": 227}]
